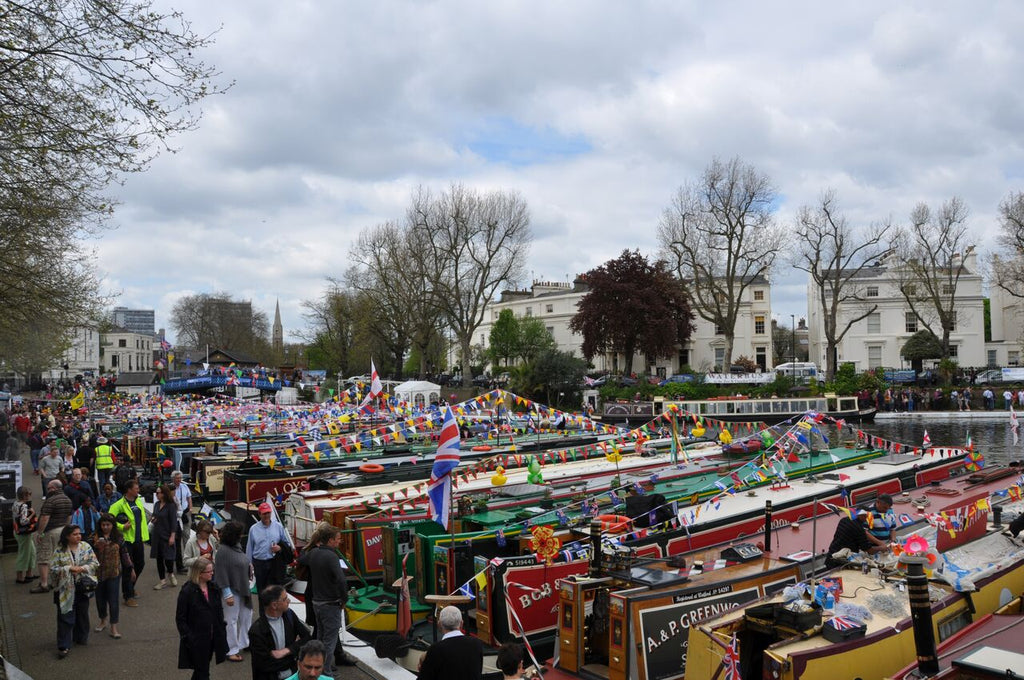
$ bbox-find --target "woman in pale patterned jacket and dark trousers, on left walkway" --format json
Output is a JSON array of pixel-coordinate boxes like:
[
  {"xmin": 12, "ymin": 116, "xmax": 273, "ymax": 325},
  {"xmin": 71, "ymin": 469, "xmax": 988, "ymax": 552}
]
[{"xmin": 52, "ymin": 524, "xmax": 99, "ymax": 658}]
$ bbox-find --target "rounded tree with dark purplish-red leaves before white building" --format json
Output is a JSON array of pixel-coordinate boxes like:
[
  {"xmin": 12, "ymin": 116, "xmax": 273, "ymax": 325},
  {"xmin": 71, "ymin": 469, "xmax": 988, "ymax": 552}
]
[{"xmin": 569, "ymin": 250, "xmax": 693, "ymax": 373}]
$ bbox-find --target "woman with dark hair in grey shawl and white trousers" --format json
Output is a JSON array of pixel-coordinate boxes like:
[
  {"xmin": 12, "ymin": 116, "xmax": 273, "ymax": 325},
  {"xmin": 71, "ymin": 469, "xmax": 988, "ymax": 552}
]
[{"xmin": 214, "ymin": 520, "xmax": 253, "ymax": 662}]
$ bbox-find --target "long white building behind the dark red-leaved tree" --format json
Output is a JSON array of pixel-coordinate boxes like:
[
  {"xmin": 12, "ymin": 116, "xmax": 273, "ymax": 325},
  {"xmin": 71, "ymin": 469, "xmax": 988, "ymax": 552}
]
[{"xmin": 474, "ymin": 280, "xmax": 772, "ymax": 377}]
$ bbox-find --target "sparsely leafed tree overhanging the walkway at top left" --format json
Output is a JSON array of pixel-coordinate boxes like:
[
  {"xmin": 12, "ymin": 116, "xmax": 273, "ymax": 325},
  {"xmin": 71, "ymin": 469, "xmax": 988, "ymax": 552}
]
[{"xmin": 0, "ymin": 0, "xmax": 223, "ymax": 372}]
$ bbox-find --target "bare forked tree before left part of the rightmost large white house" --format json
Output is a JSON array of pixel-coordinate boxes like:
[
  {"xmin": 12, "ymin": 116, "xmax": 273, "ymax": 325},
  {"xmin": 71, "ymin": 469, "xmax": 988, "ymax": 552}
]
[{"xmin": 793, "ymin": 189, "xmax": 893, "ymax": 380}]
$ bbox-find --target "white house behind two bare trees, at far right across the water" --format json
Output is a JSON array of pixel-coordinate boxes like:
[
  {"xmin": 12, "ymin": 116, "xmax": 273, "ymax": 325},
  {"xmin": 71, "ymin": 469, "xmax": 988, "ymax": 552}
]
[{"xmin": 807, "ymin": 252, "xmax": 987, "ymax": 372}]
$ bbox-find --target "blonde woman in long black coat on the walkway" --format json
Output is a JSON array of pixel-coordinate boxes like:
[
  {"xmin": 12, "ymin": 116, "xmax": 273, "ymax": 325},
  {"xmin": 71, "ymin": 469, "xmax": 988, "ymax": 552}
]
[{"xmin": 174, "ymin": 557, "xmax": 227, "ymax": 680}]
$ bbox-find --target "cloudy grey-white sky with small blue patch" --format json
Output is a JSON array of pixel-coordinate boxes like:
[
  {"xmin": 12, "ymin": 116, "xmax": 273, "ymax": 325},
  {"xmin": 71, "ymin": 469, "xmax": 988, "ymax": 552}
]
[{"xmin": 96, "ymin": 0, "xmax": 1024, "ymax": 339}]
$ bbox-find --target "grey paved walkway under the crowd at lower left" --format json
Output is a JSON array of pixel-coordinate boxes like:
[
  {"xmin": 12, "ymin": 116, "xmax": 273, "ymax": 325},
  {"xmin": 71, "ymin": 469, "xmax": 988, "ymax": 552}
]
[{"xmin": 0, "ymin": 440, "xmax": 374, "ymax": 680}]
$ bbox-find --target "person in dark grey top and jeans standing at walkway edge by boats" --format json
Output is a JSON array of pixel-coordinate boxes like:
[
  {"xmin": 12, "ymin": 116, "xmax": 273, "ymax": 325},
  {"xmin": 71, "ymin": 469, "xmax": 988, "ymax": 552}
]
[{"xmin": 299, "ymin": 526, "xmax": 348, "ymax": 675}]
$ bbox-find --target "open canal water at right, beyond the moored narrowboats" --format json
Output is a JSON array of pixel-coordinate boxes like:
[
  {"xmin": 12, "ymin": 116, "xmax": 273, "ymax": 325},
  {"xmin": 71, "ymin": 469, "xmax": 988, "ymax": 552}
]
[{"xmin": 853, "ymin": 413, "xmax": 1024, "ymax": 465}]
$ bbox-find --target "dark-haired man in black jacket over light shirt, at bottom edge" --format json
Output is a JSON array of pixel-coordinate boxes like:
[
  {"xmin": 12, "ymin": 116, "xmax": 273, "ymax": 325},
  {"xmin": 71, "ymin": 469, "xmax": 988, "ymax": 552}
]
[{"xmin": 249, "ymin": 586, "xmax": 310, "ymax": 680}]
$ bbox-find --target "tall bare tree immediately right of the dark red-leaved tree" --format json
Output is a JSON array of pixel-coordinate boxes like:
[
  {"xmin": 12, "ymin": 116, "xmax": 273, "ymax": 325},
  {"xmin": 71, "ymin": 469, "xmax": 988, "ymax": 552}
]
[{"xmin": 658, "ymin": 157, "xmax": 785, "ymax": 367}]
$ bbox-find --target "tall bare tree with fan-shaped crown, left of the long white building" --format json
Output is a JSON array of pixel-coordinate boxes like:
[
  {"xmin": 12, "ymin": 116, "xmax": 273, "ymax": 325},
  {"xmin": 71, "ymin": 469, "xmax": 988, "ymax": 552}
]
[{"xmin": 409, "ymin": 184, "xmax": 532, "ymax": 387}]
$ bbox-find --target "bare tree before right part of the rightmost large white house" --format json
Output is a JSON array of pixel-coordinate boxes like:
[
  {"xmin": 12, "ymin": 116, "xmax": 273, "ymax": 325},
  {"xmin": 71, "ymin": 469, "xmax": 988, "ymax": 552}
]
[{"xmin": 894, "ymin": 197, "xmax": 974, "ymax": 358}]
